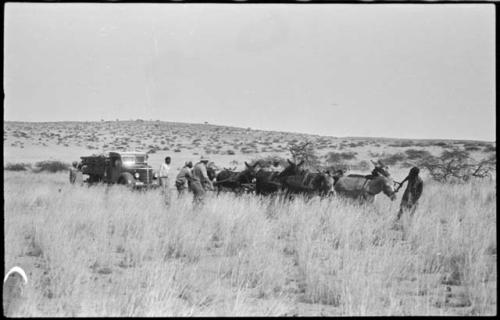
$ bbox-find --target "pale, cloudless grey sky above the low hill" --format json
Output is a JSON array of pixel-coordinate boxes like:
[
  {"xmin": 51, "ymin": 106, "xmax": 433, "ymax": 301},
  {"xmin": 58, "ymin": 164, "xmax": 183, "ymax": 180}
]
[{"xmin": 4, "ymin": 3, "xmax": 496, "ymax": 141}]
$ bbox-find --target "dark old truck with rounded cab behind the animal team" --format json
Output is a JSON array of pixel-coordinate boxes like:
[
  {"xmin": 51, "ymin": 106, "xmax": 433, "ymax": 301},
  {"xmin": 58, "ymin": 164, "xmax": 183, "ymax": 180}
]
[{"xmin": 76, "ymin": 151, "xmax": 159, "ymax": 189}]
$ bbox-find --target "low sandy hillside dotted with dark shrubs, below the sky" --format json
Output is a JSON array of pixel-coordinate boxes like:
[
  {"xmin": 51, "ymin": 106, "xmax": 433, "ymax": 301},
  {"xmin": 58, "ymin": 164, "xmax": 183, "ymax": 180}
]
[{"xmin": 4, "ymin": 119, "xmax": 496, "ymax": 174}]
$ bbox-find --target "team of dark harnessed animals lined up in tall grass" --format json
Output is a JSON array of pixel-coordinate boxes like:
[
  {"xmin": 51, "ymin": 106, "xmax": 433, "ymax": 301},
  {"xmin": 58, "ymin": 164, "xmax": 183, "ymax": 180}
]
[{"xmin": 208, "ymin": 160, "xmax": 399, "ymax": 202}]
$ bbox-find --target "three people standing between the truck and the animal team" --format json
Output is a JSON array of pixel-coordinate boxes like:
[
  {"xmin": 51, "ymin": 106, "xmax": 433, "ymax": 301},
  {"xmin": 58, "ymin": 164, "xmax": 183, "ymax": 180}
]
[{"xmin": 159, "ymin": 157, "xmax": 214, "ymax": 204}]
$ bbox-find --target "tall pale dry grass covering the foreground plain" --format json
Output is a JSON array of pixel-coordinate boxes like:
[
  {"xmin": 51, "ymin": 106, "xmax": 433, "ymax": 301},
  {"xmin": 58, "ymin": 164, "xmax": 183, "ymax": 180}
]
[{"xmin": 4, "ymin": 171, "xmax": 497, "ymax": 317}]
